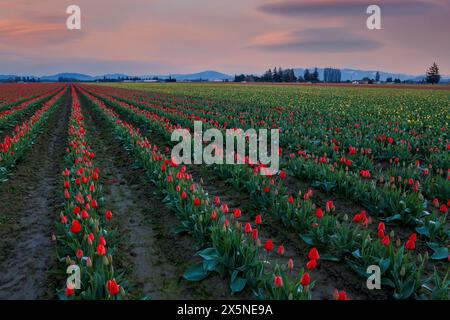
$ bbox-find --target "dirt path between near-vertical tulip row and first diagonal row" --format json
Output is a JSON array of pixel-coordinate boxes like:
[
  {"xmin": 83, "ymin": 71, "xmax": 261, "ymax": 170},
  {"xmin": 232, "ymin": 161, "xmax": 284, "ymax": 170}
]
[{"xmin": 82, "ymin": 100, "xmax": 242, "ymax": 300}]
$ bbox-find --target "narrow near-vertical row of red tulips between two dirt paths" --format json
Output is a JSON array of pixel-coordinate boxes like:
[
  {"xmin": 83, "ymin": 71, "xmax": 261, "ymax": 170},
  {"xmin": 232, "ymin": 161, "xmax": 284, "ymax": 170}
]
[{"xmin": 57, "ymin": 86, "xmax": 125, "ymax": 300}]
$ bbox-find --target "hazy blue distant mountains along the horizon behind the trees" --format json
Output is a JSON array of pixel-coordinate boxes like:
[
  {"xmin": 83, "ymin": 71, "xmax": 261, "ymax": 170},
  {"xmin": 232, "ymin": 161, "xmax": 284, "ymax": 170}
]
[{"xmin": 0, "ymin": 67, "xmax": 450, "ymax": 83}]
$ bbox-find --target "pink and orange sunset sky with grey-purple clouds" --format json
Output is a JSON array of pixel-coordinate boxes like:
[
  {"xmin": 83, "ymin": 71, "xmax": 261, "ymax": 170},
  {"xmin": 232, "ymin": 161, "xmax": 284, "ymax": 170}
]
[{"xmin": 0, "ymin": 0, "xmax": 450, "ymax": 76}]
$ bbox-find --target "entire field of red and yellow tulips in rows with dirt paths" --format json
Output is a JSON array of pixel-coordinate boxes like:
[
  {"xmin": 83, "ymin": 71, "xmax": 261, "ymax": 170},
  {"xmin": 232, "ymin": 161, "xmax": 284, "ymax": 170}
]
[{"xmin": 0, "ymin": 83, "xmax": 450, "ymax": 300}]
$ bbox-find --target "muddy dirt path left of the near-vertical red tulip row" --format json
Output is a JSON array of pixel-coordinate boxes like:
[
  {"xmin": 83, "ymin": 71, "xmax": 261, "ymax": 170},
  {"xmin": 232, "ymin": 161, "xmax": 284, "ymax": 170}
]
[{"xmin": 0, "ymin": 90, "xmax": 70, "ymax": 300}]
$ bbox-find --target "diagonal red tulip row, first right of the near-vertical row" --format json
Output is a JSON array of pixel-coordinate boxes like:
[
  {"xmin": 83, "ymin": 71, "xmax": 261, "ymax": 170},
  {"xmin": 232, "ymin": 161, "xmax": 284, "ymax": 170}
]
[{"xmin": 75, "ymin": 85, "xmax": 356, "ymax": 299}]
